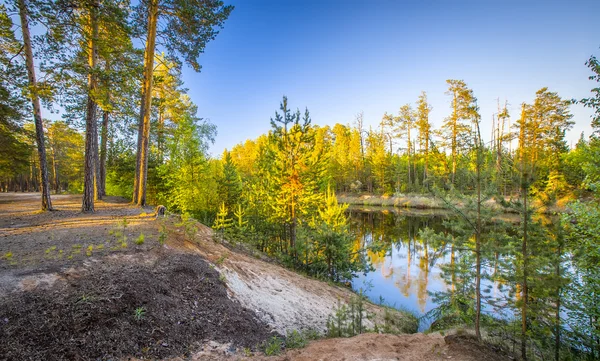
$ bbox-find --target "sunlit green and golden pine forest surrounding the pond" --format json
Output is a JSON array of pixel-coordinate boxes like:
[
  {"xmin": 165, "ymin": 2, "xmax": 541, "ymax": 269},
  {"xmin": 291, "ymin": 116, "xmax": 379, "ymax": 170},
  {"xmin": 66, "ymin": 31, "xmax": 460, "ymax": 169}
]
[{"xmin": 0, "ymin": 0, "xmax": 600, "ymax": 360}]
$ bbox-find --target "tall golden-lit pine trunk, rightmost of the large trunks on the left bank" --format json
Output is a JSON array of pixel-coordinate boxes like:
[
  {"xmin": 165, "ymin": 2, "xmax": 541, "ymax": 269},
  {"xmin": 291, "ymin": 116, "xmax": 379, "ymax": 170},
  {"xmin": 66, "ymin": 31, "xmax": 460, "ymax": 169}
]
[{"xmin": 133, "ymin": 0, "xmax": 158, "ymax": 206}]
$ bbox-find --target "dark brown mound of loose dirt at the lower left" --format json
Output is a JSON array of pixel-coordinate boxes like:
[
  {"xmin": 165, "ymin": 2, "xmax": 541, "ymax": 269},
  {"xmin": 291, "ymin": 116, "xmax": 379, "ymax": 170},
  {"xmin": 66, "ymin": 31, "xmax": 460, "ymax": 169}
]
[{"xmin": 0, "ymin": 252, "xmax": 270, "ymax": 360}]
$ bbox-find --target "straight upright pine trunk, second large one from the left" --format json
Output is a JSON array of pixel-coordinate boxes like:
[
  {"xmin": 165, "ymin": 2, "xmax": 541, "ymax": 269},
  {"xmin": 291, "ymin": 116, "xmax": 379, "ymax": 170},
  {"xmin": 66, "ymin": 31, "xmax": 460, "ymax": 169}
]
[{"xmin": 81, "ymin": 0, "xmax": 98, "ymax": 212}]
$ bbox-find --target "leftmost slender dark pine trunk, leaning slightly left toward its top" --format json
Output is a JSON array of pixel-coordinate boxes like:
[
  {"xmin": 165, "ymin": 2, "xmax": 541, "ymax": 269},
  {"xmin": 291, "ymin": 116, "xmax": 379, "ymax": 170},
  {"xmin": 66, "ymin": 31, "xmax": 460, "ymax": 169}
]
[{"xmin": 18, "ymin": 0, "xmax": 53, "ymax": 211}]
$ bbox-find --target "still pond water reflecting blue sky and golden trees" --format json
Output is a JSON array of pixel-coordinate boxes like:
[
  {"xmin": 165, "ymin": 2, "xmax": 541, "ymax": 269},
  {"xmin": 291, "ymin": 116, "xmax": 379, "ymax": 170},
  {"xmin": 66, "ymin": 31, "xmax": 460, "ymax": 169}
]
[{"xmin": 348, "ymin": 207, "xmax": 510, "ymax": 331}]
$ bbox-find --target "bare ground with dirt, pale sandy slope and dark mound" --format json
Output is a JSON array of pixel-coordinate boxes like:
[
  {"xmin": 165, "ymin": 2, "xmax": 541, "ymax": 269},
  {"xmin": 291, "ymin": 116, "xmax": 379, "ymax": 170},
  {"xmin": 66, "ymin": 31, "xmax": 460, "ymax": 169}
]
[{"xmin": 0, "ymin": 193, "xmax": 507, "ymax": 360}]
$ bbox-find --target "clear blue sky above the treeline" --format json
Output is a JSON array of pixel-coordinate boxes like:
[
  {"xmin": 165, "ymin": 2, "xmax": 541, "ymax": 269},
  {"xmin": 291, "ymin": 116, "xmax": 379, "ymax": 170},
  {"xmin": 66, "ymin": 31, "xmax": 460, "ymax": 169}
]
[{"xmin": 183, "ymin": 0, "xmax": 600, "ymax": 156}]
